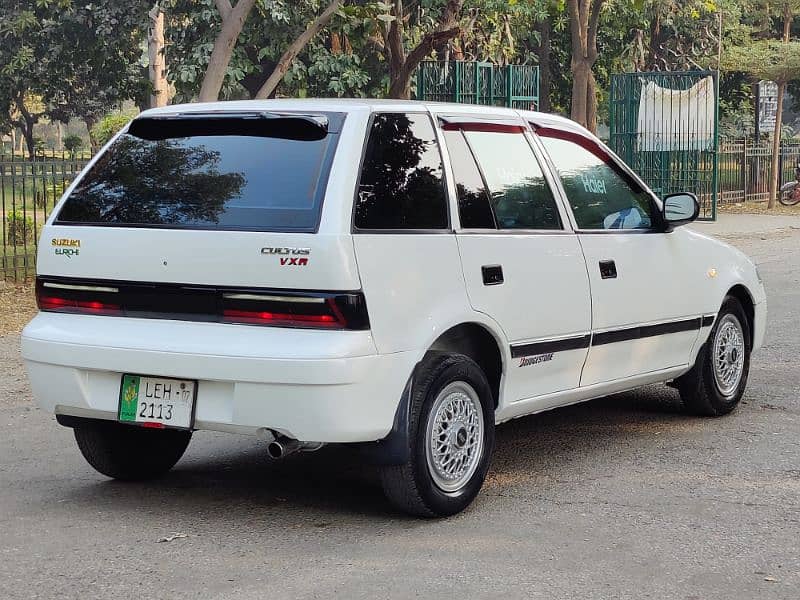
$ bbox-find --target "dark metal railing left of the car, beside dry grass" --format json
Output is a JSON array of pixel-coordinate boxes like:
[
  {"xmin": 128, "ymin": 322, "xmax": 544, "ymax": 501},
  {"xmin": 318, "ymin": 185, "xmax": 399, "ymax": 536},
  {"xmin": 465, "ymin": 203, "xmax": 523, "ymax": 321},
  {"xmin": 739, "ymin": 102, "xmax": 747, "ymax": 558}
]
[{"xmin": 0, "ymin": 153, "xmax": 87, "ymax": 281}]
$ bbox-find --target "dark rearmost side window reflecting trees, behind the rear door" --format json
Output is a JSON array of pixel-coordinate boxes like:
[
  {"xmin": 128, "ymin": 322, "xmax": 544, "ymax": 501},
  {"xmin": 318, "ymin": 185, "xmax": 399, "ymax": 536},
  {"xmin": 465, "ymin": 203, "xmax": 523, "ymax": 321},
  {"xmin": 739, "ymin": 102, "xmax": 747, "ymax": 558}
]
[{"xmin": 354, "ymin": 113, "xmax": 448, "ymax": 229}]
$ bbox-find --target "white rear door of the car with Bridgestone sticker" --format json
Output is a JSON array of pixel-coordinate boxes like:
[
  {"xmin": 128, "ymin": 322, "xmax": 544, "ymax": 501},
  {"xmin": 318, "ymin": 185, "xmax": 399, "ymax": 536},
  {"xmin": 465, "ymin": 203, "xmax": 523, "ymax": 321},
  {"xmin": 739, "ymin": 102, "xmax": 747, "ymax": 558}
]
[{"xmin": 442, "ymin": 118, "xmax": 591, "ymax": 402}]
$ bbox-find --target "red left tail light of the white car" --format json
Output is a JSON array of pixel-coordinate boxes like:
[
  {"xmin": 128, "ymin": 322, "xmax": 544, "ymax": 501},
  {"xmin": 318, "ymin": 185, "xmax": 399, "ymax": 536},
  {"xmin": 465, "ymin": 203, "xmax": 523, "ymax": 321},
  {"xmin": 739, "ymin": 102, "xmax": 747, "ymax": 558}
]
[{"xmin": 36, "ymin": 280, "xmax": 122, "ymax": 315}]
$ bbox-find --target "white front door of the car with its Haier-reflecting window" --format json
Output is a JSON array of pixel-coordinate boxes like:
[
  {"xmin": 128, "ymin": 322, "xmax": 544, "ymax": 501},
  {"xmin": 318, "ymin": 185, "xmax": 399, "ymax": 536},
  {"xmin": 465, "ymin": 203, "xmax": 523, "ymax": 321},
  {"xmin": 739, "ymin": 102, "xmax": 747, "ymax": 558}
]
[{"xmin": 536, "ymin": 127, "xmax": 702, "ymax": 386}]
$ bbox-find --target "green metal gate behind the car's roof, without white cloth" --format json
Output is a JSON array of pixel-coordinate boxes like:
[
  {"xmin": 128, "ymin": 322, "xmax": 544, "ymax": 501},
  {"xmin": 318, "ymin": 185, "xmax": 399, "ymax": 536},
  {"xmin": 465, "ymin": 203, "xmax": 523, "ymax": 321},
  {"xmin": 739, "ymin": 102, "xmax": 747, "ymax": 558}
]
[{"xmin": 417, "ymin": 60, "xmax": 539, "ymax": 110}]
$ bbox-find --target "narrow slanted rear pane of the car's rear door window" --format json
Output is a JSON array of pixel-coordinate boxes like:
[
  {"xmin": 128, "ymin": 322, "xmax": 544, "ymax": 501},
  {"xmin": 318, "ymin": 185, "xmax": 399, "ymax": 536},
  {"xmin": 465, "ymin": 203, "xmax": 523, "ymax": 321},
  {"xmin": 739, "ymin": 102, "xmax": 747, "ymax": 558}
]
[{"xmin": 444, "ymin": 130, "xmax": 497, "ymax": 229}]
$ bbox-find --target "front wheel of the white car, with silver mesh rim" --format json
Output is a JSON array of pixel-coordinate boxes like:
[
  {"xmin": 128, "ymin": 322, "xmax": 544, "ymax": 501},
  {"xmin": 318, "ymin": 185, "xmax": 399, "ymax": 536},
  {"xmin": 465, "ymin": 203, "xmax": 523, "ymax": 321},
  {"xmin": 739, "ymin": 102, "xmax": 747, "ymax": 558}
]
[{"xmin": 675, "ymin": 296, "xmax": 752, "ymax": 417}]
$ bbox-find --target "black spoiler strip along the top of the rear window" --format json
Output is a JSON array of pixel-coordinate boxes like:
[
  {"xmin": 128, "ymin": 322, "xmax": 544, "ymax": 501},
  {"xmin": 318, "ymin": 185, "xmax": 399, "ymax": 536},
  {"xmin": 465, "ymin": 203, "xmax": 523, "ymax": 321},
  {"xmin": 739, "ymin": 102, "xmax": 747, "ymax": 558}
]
[{"xmin": 128, "ymin": 111, "xmax": 328, "ymax": 141}]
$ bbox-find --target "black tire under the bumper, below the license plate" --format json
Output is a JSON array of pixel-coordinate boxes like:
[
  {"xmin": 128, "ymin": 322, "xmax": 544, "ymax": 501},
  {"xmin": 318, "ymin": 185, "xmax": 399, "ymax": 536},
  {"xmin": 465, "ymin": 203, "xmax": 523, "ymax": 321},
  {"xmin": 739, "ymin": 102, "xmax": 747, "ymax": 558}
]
[{"xmin": 74, "ymin": 421, "xmax": 192, "ymax": 481}]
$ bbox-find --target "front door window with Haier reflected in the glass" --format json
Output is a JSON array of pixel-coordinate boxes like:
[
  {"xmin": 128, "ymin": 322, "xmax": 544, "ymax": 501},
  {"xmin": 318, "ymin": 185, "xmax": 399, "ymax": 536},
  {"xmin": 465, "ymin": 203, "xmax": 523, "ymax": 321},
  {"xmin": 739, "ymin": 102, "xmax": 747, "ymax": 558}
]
[{"xmin": 536, "ymin": 128, "xmax": 654, "ymax": 229}]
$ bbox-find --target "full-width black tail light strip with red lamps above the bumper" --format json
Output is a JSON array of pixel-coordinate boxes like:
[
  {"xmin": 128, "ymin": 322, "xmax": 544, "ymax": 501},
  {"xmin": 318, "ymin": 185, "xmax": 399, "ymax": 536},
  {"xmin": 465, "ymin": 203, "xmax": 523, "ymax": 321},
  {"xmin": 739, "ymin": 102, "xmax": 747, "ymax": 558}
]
[{"xmin": 36, "ymin": 278, "xmax": 369, "ymax": 330}]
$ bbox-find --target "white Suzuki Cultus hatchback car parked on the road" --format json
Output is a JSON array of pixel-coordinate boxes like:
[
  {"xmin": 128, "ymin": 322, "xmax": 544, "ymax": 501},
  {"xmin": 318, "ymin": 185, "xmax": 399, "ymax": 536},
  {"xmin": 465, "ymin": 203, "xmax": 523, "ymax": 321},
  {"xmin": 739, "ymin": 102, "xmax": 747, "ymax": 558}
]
[{"xmin": 22, "ymin": 100, "xmax": 766, "ymax": 516}]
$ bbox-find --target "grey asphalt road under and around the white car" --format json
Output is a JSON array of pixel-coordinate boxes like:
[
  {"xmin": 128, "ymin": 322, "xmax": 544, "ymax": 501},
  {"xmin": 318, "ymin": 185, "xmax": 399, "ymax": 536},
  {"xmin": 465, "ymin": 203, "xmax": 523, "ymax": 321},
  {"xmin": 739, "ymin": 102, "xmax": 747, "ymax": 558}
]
[{"xmin": 0, "ymin": 231, "xmax": 800, "ymax": 600}]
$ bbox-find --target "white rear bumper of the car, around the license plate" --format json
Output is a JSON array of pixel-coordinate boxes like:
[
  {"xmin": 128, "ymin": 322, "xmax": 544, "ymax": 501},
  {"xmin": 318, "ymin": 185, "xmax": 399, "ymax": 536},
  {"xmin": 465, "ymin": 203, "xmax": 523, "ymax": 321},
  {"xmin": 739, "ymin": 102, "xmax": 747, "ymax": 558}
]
[{"xmin": 22, "ymin": 313, "xmax": 416, "ymax": 442}]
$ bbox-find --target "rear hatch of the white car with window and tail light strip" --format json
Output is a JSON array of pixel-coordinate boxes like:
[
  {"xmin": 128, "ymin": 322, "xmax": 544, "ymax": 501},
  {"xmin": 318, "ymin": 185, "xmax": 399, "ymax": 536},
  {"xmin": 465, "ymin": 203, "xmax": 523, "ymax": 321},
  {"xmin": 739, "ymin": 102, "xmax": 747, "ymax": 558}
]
[{"xmin": 37, "ymin": 111, "xmax": 368, "ymax": 329}]
